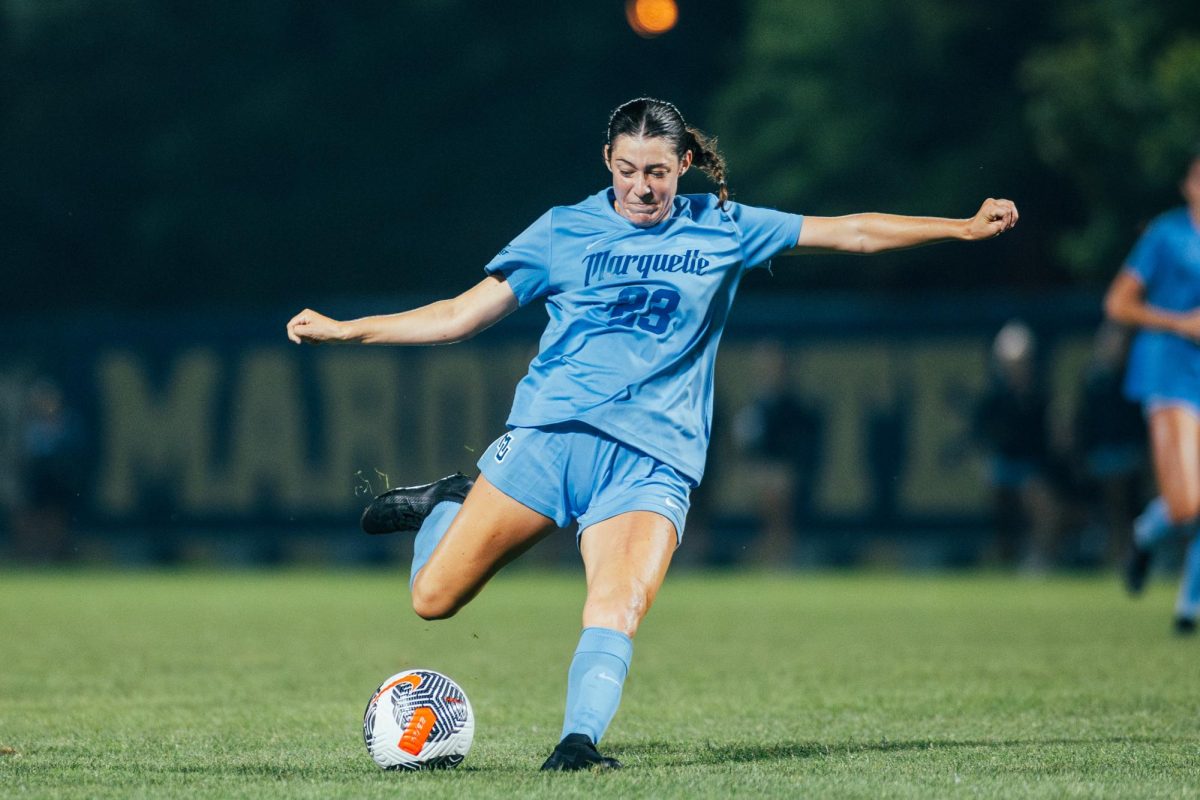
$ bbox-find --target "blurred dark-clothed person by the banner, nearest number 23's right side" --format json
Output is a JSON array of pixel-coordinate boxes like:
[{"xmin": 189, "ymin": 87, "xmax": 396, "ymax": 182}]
[{"xmin": 733, "ymin": 339, "xmax": 822, "ymax": 566}]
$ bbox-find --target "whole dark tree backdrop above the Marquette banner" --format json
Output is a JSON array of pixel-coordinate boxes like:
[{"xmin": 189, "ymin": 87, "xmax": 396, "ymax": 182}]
[{"xmin": 7, "ymin": 0, "xmax": 1200, "ymax": 309}]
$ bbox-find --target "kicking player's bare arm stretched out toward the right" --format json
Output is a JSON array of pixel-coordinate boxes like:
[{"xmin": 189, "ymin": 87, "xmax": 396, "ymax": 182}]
[{"xmin": 788, "ymin": 198, "xmax": 1019, "ymax": 254}]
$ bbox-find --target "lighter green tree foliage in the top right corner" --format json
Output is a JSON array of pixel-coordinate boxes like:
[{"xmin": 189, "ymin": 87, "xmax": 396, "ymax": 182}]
[{"xmin": 1022, "ymin": 0, "xmax": 1200, "ymax": 278}]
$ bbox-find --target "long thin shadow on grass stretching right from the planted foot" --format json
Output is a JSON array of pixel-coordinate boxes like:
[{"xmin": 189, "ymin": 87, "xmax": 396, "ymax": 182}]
[{"xmin": 608, "ymin": 736, "xmax": 1169, "ymax": 766}]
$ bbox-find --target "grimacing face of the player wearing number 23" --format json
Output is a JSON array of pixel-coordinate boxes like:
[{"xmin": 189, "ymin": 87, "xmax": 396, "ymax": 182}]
[{"xmin": 605, "ymin": 136, "xmax": 691, "ymax": 228}]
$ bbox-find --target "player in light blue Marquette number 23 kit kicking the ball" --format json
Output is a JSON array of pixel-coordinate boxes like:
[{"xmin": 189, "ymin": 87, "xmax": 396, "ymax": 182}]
[{"xmin": 288, "ymin": 98, "xmax": 1016, "ymax": 770}]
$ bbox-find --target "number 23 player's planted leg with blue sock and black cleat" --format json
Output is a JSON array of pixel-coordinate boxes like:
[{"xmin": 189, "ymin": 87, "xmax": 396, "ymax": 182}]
[{"xmin": 542, "ymin": 511, "xmax": 678, "ymax": 770}]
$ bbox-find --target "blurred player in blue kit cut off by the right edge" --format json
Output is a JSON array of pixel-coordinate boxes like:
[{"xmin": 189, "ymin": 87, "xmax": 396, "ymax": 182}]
[{"xmin": 1104, "ymin": 152, "xmax": 1200, "ymax": 633}]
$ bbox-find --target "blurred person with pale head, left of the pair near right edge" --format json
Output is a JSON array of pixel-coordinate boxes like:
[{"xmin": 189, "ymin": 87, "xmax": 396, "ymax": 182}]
[{"xmin": 973, "ymin": 319, "xmax": 1058, "ymax": 572}]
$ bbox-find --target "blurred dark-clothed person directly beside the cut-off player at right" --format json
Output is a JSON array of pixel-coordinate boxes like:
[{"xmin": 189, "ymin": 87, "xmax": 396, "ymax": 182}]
[{"xmin": 1073, "ymin": 321, "xmax": 1146, "ymax": 565}]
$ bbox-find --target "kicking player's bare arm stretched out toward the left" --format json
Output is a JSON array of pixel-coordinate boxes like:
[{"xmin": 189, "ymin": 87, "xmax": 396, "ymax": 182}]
[{"xmin": 288, "ymin": 276, "xmax": 518, "ymax": 344}]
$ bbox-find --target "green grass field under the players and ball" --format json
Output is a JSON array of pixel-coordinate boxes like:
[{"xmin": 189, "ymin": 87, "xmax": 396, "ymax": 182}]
[{"xmin": 0, "ymin": 571, "xmax": 1200, "ymax": 798}]
